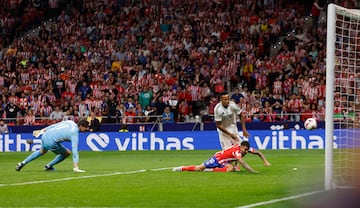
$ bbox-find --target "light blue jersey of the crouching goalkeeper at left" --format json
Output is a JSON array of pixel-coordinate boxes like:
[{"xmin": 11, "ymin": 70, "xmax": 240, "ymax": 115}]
[{"xmin": 41, "ymin": 120, "xmax": 79, "ymax": 163}]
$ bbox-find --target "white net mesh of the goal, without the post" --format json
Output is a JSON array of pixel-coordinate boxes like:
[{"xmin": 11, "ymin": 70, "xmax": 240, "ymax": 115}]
[{"xmin": 333, "ymin": 4, "xmax": 360, "ymax": 186}]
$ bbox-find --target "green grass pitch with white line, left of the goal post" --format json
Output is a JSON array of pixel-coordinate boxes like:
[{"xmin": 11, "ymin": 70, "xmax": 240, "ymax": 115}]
[{"xmin": 0, "ymin": 150, "xmax": 324, "ymax": 207}]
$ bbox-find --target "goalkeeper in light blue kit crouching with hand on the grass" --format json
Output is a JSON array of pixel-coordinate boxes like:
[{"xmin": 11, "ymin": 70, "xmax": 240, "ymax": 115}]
[{"xmin": 15, "ymin": 120, "xmax": 89, "ymax": 172}]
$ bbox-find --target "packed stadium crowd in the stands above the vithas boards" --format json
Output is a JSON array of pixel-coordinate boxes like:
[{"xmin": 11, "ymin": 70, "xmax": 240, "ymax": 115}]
[{"xmin": 0, "ymin": 0, "xmax": 360, "ymax": 125}]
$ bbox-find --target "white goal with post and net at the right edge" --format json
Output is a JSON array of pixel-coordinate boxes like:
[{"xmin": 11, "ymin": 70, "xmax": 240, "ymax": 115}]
[{"xmin": 325, "ymin": 4, "xmax": 360, "ymax": 189}]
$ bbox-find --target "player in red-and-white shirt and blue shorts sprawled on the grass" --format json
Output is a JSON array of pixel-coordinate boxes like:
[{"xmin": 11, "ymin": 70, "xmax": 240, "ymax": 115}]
[{"xmin": 173, "ymin": 141, "xmax": 257, "ymax": 173}]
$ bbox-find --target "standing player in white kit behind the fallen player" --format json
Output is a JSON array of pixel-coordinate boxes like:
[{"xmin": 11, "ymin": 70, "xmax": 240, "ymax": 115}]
[{"xmin": 214, "ymin": 92, "xmax": 271, "ymax": 166}]
